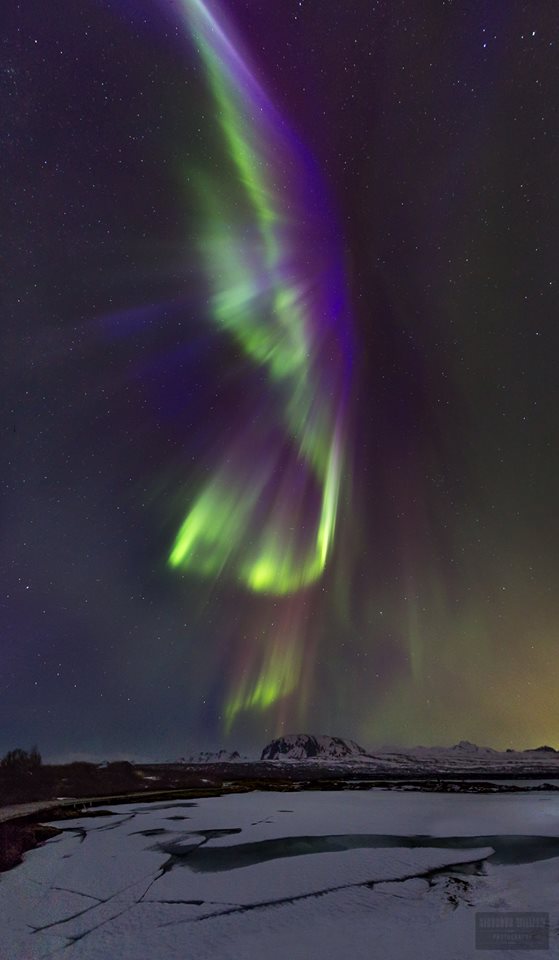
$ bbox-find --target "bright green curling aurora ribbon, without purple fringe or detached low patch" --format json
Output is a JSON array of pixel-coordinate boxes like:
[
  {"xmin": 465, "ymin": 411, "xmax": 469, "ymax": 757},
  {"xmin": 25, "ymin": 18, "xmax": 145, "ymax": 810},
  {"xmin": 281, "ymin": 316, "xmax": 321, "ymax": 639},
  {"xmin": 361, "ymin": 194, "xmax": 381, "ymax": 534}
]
[{"xmin": 168, "ymin": 0, "xmax": 341, "ymax": 608}]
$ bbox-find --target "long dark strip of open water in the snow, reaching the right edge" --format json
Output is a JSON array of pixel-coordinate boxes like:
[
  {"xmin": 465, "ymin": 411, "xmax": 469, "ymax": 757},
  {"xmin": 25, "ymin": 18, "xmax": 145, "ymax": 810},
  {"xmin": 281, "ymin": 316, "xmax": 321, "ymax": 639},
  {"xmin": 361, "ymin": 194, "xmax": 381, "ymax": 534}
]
[{"xmin": 152, "ymin": 829, "xmax": 559, "ymax": 873}]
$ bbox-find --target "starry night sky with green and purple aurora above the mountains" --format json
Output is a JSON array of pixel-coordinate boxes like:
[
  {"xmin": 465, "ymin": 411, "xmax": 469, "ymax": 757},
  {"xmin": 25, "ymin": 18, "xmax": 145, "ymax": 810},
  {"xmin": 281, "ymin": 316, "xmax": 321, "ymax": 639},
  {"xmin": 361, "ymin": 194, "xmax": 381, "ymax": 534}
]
[{"xmin": 4, "ymin": 0, "xmax": 559, "ymax": 759}]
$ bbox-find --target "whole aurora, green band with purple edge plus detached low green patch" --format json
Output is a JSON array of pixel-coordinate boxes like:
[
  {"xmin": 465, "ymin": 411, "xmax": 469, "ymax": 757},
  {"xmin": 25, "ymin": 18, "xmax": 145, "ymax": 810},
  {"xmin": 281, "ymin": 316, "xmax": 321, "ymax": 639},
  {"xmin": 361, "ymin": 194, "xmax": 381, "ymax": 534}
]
[{"xmin": 168, "ymin": 0, "xmax": 351, "ymax": 725}]
